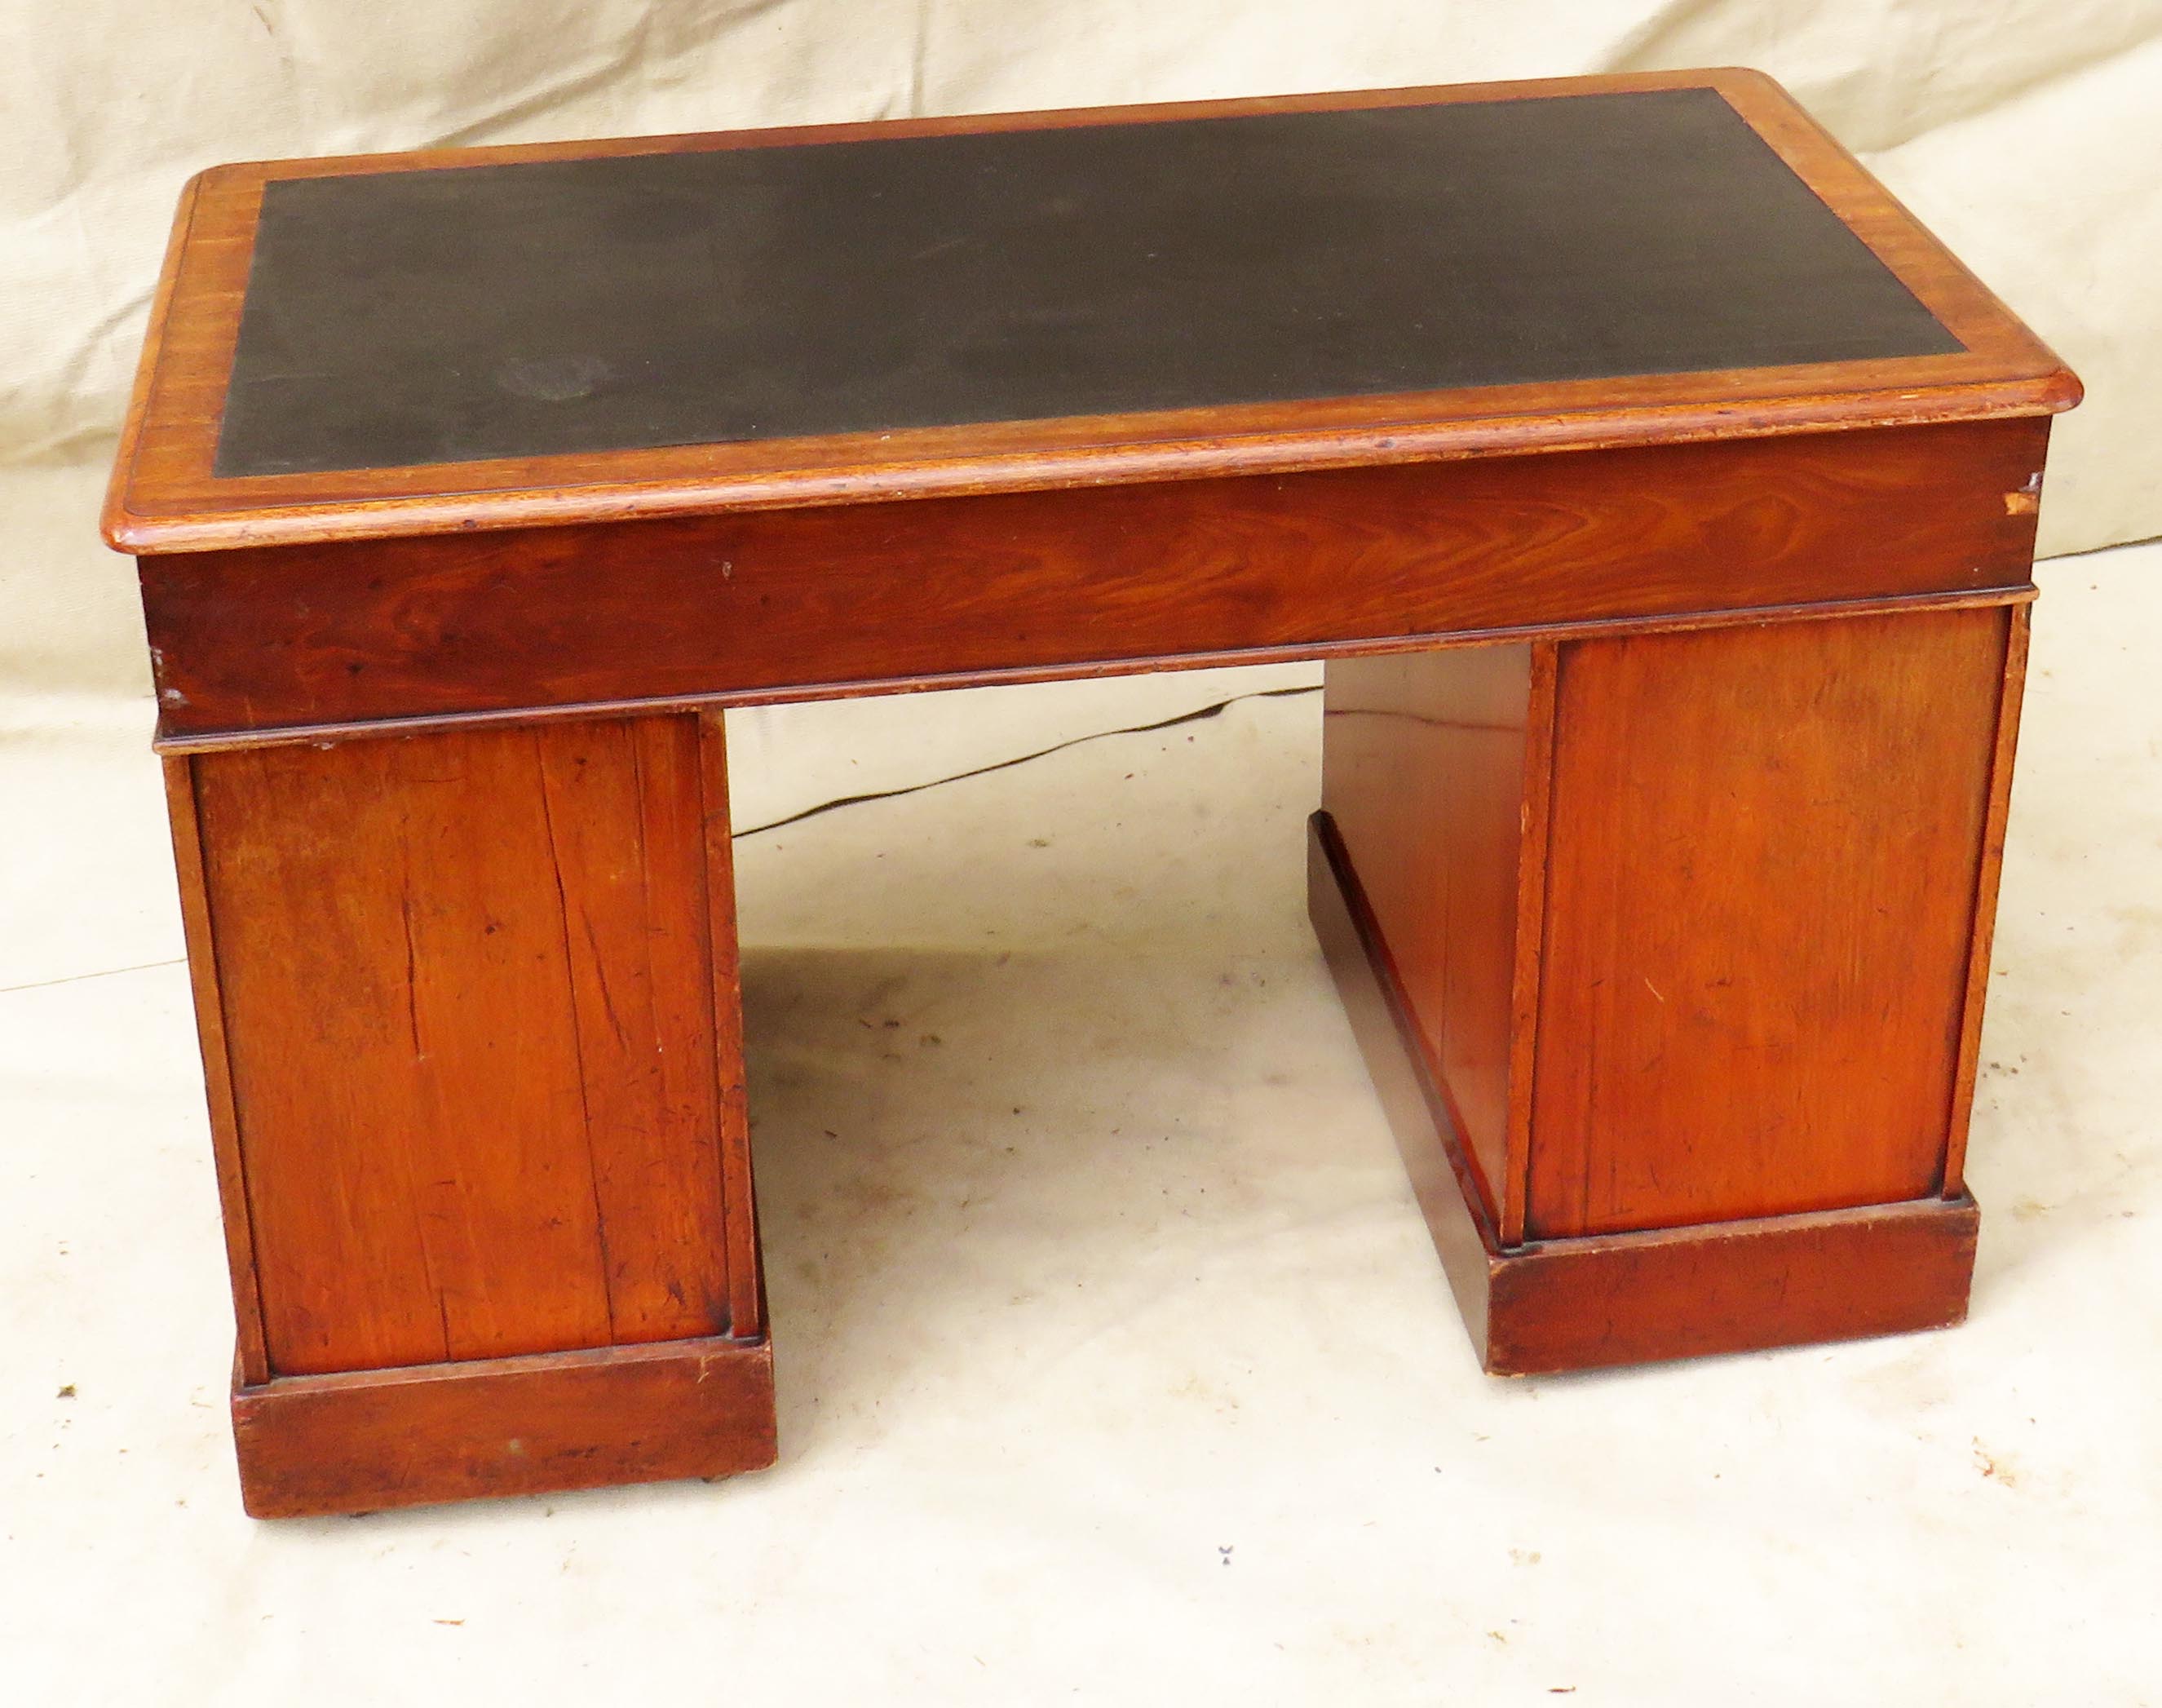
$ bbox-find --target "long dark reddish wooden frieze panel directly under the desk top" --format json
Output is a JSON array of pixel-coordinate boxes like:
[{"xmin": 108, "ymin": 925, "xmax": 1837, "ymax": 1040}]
[{"xmin": 140, "ymin": 422, "xmax": 2047, "ymax": 740}]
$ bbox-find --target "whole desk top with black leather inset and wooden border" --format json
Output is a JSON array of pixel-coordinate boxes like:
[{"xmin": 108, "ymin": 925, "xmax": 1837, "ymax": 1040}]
[{"xmin": 106, "ymin": 71, "xmax": 2078, "ymax": 551}]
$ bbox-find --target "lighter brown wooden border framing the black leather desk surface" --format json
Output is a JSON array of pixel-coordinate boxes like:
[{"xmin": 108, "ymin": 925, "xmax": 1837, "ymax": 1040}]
[{"xmin": 104, "ymin": 71, "xmax": 2080, "ymax": 554}]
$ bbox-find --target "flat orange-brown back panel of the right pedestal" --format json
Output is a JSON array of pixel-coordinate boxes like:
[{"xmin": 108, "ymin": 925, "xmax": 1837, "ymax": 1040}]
[{"xmin": 1527, "ymin": 609, "xmax": 2009, "ymax": 1239}]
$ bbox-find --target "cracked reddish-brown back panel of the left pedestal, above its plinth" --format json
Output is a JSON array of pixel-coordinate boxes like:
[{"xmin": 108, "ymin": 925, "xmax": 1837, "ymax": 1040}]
[{"xmin": 192, "ymin": 718, "xmax": 740, "ymax": 1375}]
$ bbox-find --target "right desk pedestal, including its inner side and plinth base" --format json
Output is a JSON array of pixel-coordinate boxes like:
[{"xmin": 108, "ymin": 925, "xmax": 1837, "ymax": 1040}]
[{"xmin": 1311, "ymin": 605, "xmax": 2026, "ymax": 1375}]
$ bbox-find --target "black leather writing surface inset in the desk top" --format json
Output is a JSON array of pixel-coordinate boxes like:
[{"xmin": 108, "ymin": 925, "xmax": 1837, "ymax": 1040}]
[{"xmin": 216, "ymin": 89, "xmax": 1961, "ymax": 476}]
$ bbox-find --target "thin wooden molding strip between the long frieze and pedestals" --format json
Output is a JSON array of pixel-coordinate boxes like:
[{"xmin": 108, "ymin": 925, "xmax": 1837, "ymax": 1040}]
[{"xmin": 152, "ymin": 582, "xmax": 2036, "ymax": 754}]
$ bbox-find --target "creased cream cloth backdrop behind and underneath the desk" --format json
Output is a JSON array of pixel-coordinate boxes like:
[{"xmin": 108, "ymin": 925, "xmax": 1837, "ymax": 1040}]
[{"xmin": 0, "ymin": 16, "xmax": 2162, "ymax": 1708}]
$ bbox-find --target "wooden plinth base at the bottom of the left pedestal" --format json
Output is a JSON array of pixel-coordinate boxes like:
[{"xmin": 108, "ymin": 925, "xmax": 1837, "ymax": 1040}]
[{"xmin": 233, "ymin": 1339, "xmax": 776, "ymax": 1518}]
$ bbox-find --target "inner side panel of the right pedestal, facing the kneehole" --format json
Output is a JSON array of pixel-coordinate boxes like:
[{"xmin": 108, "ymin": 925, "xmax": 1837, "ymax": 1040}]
[{"xmin": 1321, "ymin": 647, "xmax": 1533, "ymax": 1222}]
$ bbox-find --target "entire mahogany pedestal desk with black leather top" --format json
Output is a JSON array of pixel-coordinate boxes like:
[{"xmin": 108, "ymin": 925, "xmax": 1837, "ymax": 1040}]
[{"xmin": 106, "ymin": 71, "xmax": 2078, "ymax": 1513}]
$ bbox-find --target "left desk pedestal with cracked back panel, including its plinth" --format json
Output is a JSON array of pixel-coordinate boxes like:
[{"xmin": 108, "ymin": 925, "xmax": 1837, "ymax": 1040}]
[{"xmin": 166, "ymin": 711, "xmax": 774, "ymax": 1516}]
